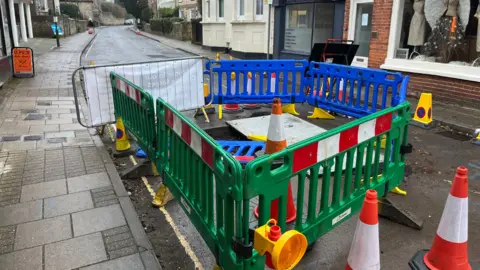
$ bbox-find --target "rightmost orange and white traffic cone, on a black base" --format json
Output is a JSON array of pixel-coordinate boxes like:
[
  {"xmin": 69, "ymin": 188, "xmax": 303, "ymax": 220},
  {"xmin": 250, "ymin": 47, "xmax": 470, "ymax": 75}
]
[{"xmin": 423, "ymin": 167, "xmax": 472, "ymax": 270}]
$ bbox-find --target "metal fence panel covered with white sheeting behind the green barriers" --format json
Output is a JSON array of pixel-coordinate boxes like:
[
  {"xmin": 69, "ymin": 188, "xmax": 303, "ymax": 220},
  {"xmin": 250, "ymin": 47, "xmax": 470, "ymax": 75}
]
[{"xmin": 74, "ymin": 57, "xmax": 205, "ymax": 126}]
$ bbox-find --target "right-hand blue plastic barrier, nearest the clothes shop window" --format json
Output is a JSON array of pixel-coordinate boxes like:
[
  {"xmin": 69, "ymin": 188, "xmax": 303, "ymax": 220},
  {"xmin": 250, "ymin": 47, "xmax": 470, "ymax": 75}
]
[{"xmin": 307, "ymin": 62, "xmax": 409, "ymax": 118}]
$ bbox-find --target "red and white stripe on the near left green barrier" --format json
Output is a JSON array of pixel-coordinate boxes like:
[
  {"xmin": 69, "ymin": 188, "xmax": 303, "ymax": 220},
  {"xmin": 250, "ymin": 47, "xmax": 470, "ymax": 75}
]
[{"xmin": 165, "ymin": 108, "xmax": 214, "ymax": 168}]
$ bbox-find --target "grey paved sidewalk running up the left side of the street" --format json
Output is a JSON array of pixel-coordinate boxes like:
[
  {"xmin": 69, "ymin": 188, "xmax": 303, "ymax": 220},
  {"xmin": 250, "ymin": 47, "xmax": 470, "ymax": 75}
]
[{"xmin": 0, "ymin": 33, "xmax": 160, "ymax": 270}]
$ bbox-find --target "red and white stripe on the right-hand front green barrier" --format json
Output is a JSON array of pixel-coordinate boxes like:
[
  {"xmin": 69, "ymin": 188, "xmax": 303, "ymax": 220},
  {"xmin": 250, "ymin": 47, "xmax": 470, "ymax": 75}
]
[{"xmin": 293, "ymin": 113, "xmax": 392, "ymax": 173}]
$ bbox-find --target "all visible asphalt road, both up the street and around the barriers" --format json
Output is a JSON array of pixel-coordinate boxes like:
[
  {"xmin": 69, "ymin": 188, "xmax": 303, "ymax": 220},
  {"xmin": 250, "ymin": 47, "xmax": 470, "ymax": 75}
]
[{"xmin": 84, "ymin": 27, "xmax": 480, "ymax": 269}]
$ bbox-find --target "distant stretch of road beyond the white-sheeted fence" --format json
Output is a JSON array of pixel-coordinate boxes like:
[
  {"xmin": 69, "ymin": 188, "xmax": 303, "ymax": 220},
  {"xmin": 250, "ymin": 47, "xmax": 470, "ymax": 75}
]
[{"xmin": 82, "ymin": 26, "xmax": 188, "ymax": 65}]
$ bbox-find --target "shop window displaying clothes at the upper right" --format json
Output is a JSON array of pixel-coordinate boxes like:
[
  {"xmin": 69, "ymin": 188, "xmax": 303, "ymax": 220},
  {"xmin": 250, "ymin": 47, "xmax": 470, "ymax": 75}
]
[{"xmin": 393, "ymin": 0, "xmax": 480, "ymax": 66}]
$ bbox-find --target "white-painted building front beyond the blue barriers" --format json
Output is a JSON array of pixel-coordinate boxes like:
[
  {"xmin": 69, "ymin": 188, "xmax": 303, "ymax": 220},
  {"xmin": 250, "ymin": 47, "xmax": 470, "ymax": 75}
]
[{"xmin": 202, "ymin": 0, "xmax": 273, "ymax": 58}]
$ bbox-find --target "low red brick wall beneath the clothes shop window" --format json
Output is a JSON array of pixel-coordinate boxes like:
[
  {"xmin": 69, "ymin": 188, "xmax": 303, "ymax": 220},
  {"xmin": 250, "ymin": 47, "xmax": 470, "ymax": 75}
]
[{"xmin": 402, "ymin": 72, "xmax": 480, "ymax": 107}]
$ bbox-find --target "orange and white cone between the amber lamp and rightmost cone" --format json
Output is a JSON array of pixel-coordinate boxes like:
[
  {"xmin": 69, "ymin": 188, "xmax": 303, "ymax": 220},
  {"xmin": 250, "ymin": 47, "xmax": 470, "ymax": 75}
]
[{"xmin": 345, "ymin": 190, "xmax": 380, "ymax": 270}]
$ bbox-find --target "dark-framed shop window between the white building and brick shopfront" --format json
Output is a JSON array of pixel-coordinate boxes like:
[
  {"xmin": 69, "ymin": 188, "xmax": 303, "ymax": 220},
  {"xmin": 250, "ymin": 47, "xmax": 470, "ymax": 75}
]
[{"xmin": 283, "ymin": 3, "xmax": 335, "ymax": 54}]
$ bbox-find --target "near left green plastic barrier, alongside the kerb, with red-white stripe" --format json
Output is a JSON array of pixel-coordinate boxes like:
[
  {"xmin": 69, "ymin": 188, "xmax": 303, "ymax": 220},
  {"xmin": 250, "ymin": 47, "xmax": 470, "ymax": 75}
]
[{"xmin": 156, "ymin": 98, "xmax": 243, "ymax": 269}]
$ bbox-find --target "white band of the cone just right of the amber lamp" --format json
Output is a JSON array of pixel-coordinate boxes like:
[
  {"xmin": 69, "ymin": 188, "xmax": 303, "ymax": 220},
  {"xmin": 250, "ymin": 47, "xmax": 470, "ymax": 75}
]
[{"xmin": 347, "ymin": 221, "xmax": 380, "ymax": 270}]
